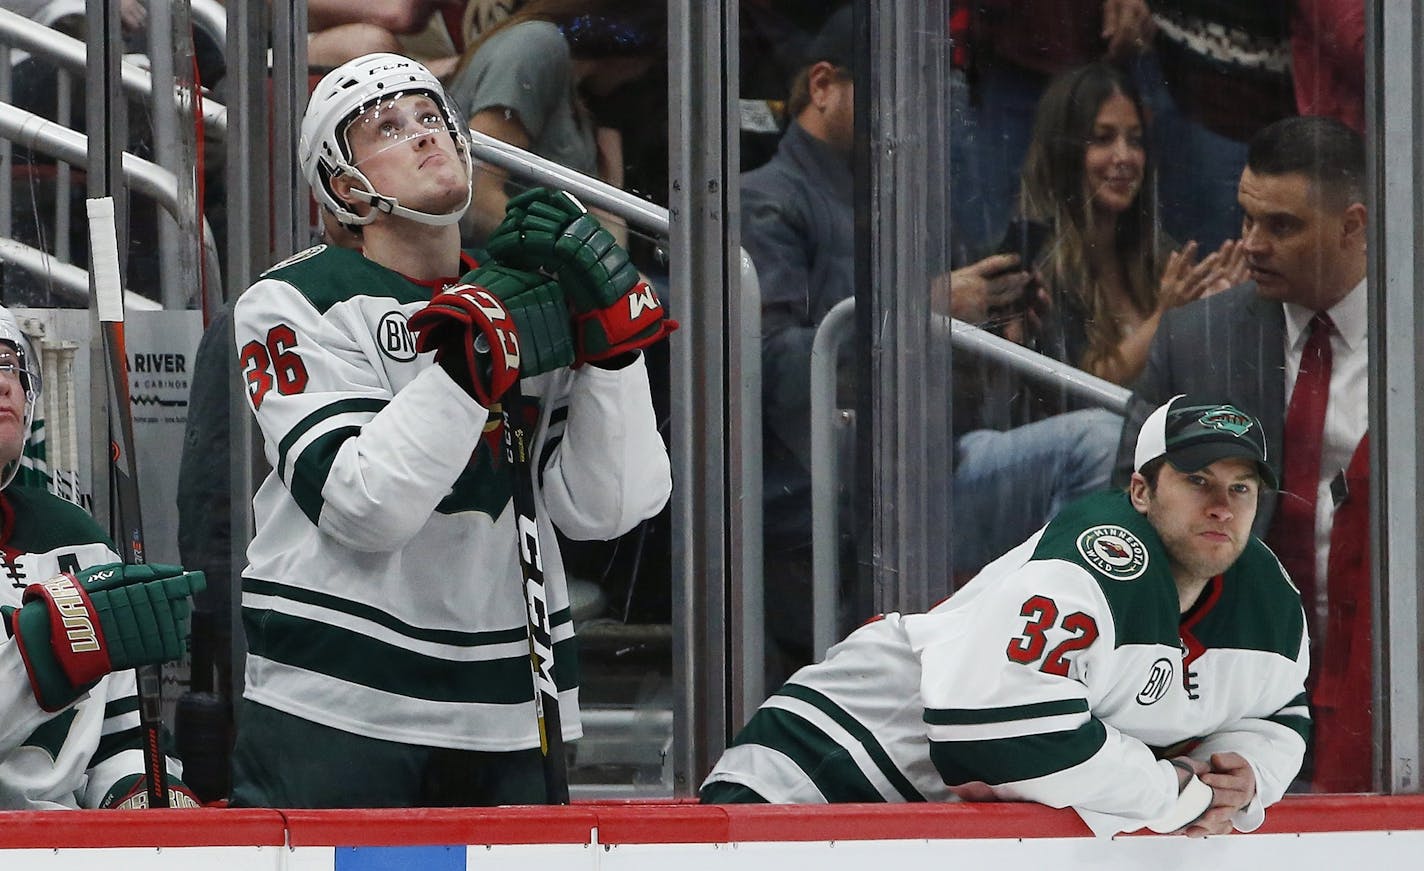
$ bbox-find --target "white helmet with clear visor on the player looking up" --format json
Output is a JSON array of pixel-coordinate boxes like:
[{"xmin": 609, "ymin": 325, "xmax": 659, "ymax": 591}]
[{"xmin": 296, "ymin": 53, "xmax": 474, "ymax": 226}]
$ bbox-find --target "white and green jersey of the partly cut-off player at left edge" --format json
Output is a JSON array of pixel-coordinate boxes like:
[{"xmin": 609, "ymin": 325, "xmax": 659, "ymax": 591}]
[{"xmin": 0, "ymin": 485, "xmax": 182, "ymax": 810}]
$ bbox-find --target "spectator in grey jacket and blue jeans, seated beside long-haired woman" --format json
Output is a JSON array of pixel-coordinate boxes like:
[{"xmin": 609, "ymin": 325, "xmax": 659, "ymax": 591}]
[{"xmin": 742, "ymin": 7, "xmax": 1119, "ymax": 677}]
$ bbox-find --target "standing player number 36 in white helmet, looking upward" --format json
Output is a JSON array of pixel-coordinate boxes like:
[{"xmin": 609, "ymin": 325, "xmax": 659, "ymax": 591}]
[{"xmin": 232, "ymin": 54, "xmax": 675, "ymax": 807}]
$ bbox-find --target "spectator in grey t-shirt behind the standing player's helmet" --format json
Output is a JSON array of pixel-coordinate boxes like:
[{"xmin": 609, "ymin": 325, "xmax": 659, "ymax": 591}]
[{"xmin": 450, "ymin": 0, "xmax": 666, "ymax": 239}]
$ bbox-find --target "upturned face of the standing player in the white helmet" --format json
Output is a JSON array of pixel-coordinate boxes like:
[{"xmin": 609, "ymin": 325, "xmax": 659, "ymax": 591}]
[{"xmin": 332, "ymin": 94, "xmax": 467, "ymax": 213}]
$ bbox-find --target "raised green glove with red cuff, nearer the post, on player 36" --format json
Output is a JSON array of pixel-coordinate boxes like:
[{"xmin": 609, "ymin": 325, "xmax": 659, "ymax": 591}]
[{"xmin": 486, "ymin": 188, "xmax": 678, "ymax": 366}]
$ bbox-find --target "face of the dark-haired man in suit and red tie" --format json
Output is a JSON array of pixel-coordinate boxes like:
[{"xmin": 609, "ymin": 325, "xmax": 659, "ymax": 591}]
[{"xmin": 1236, "ymin": 167, "xmax": 1364, "ymax": 310}]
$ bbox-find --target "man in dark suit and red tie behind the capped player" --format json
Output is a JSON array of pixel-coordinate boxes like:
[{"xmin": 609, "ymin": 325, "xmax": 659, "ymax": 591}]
[{"xmin": 1119, "ymin": 117, "xmax": 1371, "ymax": 791}]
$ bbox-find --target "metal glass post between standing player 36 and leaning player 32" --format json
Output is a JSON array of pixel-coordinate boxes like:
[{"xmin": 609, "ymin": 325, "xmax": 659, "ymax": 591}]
[{"xmin": 668, "ymin": 0, "xmax": 740, "ymax": 796}]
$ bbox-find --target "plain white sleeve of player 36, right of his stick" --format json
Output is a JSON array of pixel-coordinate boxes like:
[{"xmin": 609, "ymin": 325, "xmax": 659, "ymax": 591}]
[{"xmin": 543, "ymin": 354, "xmax": 672, "ymax": 541}]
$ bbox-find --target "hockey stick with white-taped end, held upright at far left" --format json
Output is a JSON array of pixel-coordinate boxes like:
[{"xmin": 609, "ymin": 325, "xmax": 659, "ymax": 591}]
[{"xmin": 85, "ymin": 196, "xmax": 168, "ymax": 807}]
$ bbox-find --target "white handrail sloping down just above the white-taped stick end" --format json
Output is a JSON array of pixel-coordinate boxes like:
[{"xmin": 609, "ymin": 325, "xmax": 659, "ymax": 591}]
[{"xmin": 0, "ymin": 102, "xmax": 221, "ymax": 309}]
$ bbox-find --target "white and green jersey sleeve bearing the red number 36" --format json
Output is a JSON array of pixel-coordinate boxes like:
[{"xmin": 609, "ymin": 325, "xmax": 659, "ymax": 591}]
[{"xmin": 234, "ymin": 279, "xmax": 488, "ymax": 552}]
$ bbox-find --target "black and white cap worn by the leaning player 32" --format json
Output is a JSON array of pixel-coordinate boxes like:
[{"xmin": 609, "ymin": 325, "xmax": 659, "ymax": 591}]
[{"xmin": 1132, "ymin": 393, "xmax": 1277, "ymax": 490}]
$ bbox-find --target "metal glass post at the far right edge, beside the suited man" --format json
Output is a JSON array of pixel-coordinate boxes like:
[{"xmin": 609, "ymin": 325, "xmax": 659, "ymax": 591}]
[{"xmin": 1364, "ymin": 1, "xmax": 1424, "ymax": 793}]
